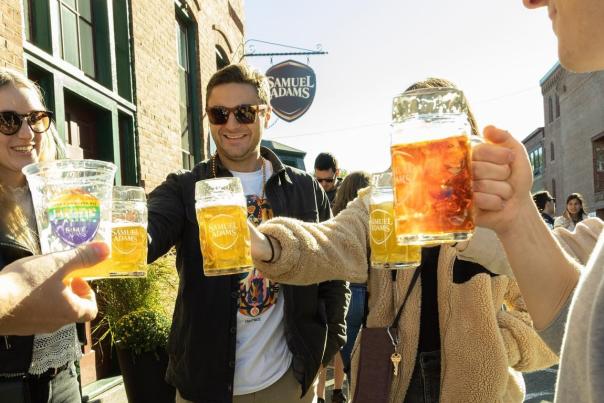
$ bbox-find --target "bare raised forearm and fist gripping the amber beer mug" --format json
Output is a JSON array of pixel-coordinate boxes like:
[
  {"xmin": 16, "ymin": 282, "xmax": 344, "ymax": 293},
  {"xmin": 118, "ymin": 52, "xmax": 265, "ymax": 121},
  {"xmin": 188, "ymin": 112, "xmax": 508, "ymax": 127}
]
[{"xmin": 472, "ymin": 126, "xmax": 580, "ymax": 329}]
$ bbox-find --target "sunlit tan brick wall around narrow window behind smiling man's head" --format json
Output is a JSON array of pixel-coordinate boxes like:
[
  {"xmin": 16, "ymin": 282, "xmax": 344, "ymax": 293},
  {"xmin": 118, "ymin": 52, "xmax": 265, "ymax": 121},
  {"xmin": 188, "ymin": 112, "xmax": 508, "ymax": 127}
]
[{"xmin": 132, "ymin": 0, "xmax": 245, "ymax": 191}]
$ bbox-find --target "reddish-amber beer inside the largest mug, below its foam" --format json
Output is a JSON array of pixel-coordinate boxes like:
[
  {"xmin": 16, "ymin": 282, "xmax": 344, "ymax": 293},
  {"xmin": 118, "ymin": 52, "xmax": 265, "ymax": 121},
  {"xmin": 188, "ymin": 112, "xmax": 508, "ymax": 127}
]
[{"xmin": 392, "ymin": 135, "xmax": 474, "ymax": 244}]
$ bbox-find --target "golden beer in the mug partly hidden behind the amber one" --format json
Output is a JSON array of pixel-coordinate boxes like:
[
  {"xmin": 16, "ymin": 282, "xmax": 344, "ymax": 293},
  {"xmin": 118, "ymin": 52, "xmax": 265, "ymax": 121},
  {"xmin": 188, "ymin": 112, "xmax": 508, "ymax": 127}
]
[{"xmin": 369, "ymin": 201, "xmax": 421, "ymax": 269}]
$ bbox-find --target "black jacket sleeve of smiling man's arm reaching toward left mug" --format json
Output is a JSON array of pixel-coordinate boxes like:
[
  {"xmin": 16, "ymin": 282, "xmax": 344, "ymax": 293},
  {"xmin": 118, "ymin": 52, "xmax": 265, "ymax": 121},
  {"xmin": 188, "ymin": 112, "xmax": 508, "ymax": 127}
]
[{"xmin": 147, "ymin": 174, "xmax": 186, "ymax": 263}]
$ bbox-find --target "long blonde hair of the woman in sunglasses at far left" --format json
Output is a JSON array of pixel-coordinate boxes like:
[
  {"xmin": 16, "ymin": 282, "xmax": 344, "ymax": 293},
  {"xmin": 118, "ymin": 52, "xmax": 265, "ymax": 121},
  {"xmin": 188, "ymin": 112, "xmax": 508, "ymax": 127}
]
[{"xmin": 0, "ymin": 68, "xmax": 65, "ymax": 253}]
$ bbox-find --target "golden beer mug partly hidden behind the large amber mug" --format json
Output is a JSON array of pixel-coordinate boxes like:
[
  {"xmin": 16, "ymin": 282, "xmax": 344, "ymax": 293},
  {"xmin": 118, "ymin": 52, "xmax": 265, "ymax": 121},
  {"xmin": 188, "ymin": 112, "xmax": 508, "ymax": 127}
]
[{"xmin": 369, "ymin": 172, "xmax": 422, "ymax": 269}]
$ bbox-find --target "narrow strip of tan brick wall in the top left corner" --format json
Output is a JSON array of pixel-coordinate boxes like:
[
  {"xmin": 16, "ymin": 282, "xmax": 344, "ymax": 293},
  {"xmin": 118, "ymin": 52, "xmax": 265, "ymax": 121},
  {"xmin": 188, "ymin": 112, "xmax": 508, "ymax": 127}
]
[{"xmin": 0, "ymin": 0, "xmax": 23, "ymax": 70}]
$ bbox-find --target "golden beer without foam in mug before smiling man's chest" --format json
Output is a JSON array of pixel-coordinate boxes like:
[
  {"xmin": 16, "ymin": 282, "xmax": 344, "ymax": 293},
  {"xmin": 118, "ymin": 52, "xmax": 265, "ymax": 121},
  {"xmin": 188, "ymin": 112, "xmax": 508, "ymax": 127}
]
[{"xmin": 197, "ymin": 205, "xmax": 253, "ymax": 276}]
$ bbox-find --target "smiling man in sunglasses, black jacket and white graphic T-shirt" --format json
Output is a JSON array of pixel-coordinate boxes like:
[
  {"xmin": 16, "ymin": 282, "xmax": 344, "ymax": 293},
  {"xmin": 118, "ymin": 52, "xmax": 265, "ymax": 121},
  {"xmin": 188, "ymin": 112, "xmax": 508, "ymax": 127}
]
[{"xmin": 148, "ymin": 65, "xmax": 349, "ymax": 403}]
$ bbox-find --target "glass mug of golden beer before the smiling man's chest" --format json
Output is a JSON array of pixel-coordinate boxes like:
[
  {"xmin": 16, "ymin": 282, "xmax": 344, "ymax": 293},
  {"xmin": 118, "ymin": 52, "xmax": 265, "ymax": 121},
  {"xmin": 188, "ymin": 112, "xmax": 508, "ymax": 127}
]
[{"xmin": 195, "ymin": 178, "xmax": 252, "ymax": 276}]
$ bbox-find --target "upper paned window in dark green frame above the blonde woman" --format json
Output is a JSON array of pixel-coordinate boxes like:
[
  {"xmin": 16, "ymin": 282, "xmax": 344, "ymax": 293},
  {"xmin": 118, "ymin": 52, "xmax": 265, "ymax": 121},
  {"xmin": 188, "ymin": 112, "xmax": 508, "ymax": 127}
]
[{"xmin": 59, "ymin": 0, "xmax": 96, "ymax": 78}]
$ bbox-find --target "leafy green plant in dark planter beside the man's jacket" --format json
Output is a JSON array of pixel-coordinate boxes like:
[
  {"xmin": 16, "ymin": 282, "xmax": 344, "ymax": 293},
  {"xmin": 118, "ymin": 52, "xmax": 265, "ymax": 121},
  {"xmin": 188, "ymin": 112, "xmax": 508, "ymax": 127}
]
[{"xmin": 93, "ymin": 253, "xmax": 178, "ymax": 354}]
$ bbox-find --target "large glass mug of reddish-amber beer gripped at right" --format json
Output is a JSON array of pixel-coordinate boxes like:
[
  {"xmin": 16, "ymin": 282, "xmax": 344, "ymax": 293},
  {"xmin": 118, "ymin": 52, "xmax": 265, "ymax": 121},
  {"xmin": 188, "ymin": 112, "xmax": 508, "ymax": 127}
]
[{"xmin": 391, "ymin": 88, "xmax": 474, "ymax": 245}]
